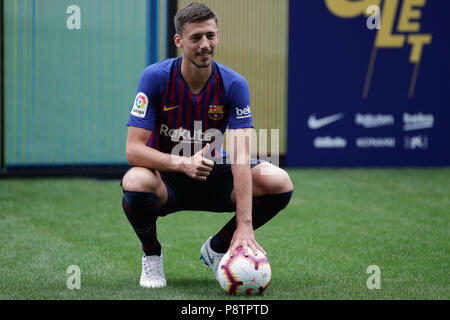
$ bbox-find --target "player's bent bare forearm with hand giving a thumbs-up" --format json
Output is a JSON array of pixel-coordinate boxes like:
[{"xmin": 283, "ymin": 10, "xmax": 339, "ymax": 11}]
[{"xmin": 126, "ymin": 126, "xmax": 214, "ymax": 181}]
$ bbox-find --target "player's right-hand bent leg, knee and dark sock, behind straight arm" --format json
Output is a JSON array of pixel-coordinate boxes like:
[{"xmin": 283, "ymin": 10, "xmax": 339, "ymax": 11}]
[{"xmin": 211, "ymin": 162, "xmax": 294, "ymax": 253}]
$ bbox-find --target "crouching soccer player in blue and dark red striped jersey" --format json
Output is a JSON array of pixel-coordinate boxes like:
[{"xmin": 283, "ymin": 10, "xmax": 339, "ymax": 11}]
[{"xmin": 121, "ymin": 3, "xmax": 293, "ymax": 288}]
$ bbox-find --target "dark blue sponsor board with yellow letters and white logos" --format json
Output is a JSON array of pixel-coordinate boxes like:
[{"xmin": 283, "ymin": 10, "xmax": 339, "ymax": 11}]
[{"xmin": 286, "ymin": 0, "xmax": 450, "ymax": 167}]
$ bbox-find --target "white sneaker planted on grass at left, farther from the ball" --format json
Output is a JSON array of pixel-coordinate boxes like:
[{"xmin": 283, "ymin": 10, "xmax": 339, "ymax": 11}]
[{"xmin": 140, "ymin": 253, "xmax": 167, "ymax": 288}]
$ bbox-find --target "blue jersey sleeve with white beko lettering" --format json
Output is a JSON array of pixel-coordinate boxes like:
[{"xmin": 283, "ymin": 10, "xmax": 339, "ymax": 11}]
[{"xmin": 228, "ymin": 77, "xmax": 253, "ymax": 129}]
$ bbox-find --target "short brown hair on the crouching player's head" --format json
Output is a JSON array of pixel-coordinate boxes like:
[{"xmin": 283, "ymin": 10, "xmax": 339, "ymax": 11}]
[{"xmin": 173, "ymin": 2, "xmax": 217, "ymax": 36}]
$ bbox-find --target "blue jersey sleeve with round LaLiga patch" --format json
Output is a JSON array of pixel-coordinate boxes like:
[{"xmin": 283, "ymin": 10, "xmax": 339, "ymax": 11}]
[{"xmin": 127, "ymin": 68, "xmax": 159, "ymax": 130}]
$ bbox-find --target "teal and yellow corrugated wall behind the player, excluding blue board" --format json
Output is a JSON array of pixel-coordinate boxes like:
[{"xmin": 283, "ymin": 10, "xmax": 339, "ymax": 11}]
[{"xmin": 1, "ymin": 0, "xmax": 288, "ymax": 176}]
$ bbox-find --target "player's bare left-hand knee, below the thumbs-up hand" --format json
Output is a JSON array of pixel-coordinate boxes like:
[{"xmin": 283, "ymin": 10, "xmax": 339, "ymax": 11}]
[{"xmin": 122, "ymin": 167, "xmax": 159, "ymax": 193}]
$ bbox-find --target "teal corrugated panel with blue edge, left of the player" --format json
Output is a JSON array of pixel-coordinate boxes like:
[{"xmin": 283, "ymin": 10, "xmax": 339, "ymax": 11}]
[{"xmin": 4, "ymin": 0, "xmax": 159, "ymax": 168}]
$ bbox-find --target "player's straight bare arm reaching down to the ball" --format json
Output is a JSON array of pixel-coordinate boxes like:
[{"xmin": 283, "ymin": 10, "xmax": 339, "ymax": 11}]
[{"xmin": 229, "ymin": 128, "xmax": 265, "ymax": 256}]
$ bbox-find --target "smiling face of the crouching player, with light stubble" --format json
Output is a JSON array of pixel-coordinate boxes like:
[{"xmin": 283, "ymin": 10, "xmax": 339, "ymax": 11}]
[{"xmin": 175, "ymin": 19, "xmax": 219, "ymax": 68}]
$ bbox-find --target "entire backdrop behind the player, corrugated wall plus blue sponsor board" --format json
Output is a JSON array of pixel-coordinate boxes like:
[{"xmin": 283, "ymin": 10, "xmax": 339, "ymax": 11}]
[{"xmin": 0, "ymin": 0, "xmax": 450, "ymax": 176}]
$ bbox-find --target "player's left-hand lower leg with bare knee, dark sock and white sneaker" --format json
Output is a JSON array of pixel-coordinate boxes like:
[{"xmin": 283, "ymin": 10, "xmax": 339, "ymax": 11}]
[{"xmin": 122, "ymin": 167, "xmax": 167, "ymax": 288}]
